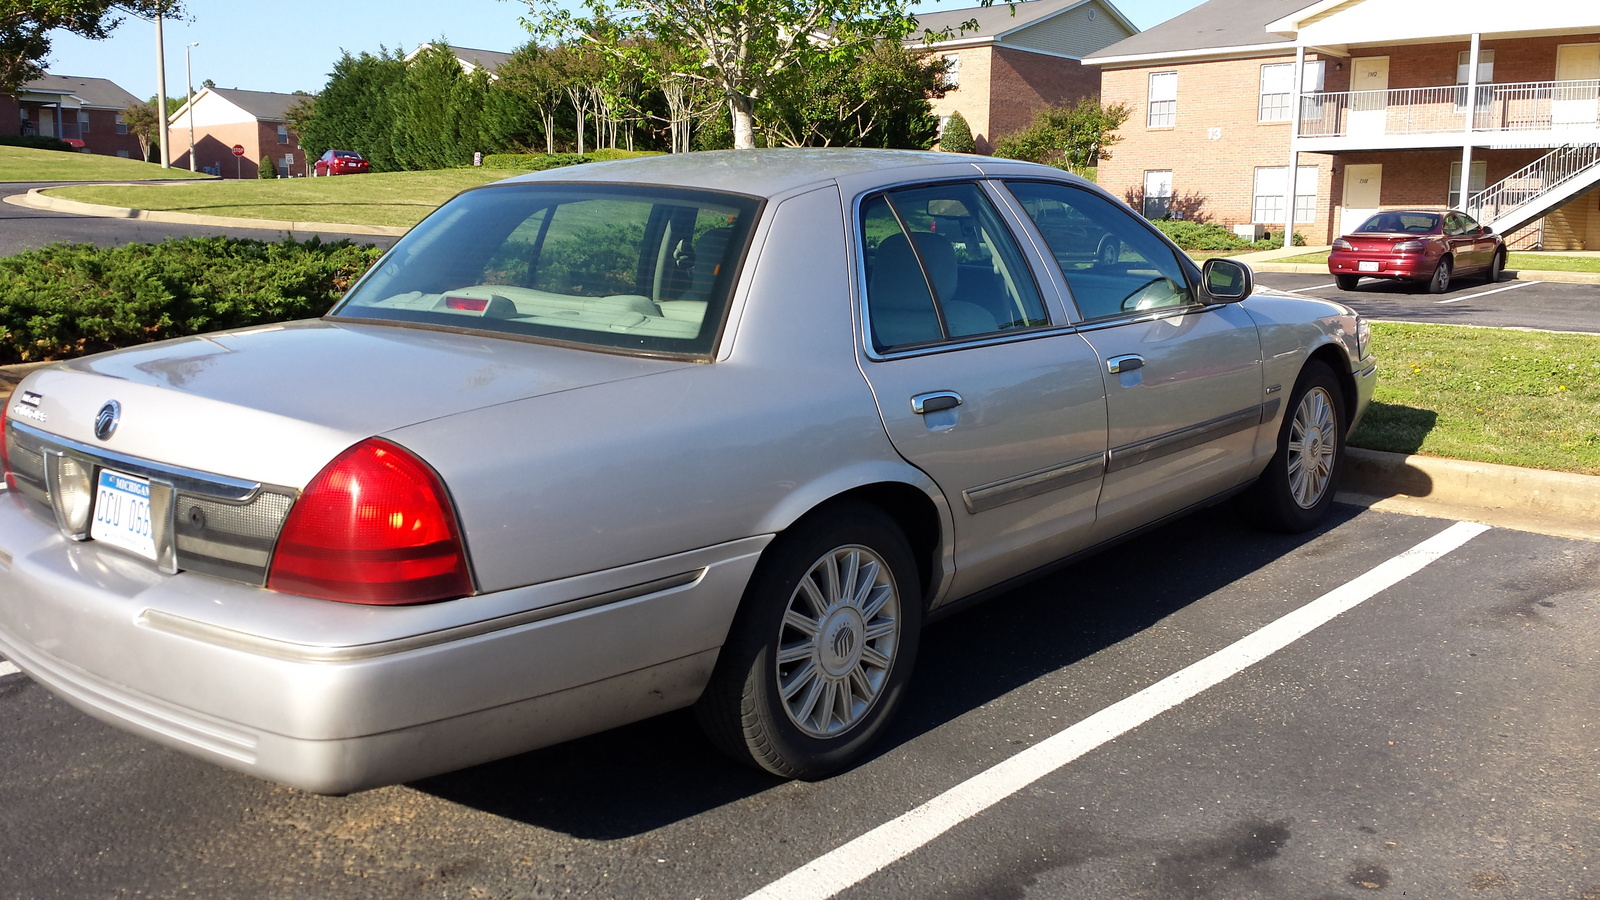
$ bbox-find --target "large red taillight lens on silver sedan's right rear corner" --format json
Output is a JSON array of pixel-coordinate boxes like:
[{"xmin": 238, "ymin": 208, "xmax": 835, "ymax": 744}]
[{"xmin": 267, "ymin": 439, "xmax": 472, "ymax": 605}]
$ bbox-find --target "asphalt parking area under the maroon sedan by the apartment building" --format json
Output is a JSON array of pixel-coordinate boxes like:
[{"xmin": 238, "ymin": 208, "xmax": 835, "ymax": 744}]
[{"xmin": 1256, "ymin": 272, "xmax": 1600, "ymax": 331}]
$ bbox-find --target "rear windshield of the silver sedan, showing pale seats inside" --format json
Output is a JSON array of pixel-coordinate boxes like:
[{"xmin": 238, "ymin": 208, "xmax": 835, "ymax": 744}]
[{"xmin": 331, "ymin": 184, "xmax": 757, "ymax": 356}]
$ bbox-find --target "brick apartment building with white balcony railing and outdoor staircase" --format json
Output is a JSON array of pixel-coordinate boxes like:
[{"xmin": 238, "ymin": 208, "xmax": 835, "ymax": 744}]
[{"xmin": 1086, "ymin": 0, "xmax": 1600, "ymax": 248}]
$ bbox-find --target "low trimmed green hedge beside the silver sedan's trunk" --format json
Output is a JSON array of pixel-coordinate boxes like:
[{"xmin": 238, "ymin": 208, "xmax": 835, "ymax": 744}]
[{"xmin": 0, "ymin": 237, "xmax": 382, "ymax": 365}]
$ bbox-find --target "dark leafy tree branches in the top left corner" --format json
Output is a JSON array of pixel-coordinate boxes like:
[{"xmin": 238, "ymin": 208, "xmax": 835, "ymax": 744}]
[{"xmin": 0, "ymin": 0, "xmax": 182, "ymax": 96}]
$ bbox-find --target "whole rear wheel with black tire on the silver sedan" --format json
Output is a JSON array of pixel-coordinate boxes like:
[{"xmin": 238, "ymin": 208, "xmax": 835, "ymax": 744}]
[{"xmin": 694, "ymin": 503, "xmax": 922, "ymax": 780}]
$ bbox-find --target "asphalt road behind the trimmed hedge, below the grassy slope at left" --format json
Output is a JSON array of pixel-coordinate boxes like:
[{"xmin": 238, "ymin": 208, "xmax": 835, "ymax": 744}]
[{"xmin": 0, "ymin": 181, "xmax": 397, "ymax": 256}]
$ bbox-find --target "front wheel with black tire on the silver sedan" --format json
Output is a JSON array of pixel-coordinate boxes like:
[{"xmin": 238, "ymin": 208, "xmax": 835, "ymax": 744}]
[{"xmin": 1246, "ymin": 360, "xmax": 1346, "ymax": 533}]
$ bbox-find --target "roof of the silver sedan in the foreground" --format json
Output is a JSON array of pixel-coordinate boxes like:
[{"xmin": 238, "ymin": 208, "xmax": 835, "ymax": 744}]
[{"xmin": 498, "ymin": 147, "xmax": 1066, "ymax": 197}]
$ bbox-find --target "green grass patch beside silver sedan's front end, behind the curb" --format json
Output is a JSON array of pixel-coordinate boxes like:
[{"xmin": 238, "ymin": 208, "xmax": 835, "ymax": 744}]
[{"xmin": 1350, "ymin": 322, "xmax": 1600, "ymax": 476}]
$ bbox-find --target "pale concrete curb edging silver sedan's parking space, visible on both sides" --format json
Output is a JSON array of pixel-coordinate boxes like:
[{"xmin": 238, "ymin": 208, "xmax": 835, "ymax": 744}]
[{"xmin": 0, "ymin": 362, "xmax": 1600, "ymax": 541}]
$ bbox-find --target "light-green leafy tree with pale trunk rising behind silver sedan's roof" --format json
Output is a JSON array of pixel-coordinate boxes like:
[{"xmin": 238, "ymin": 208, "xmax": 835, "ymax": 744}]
[{"xmin": 525, "ymin": 0, "xmax": 915, "ymax": 149}]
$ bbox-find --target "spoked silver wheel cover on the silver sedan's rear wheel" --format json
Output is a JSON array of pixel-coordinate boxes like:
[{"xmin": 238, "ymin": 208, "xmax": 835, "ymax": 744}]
[{"xmin": 776, "ymin": 544, "xmax": 901, "ymax": 738}]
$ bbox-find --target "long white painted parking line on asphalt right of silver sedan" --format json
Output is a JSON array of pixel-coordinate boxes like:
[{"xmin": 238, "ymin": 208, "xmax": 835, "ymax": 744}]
[{"xmin": 746, "ymin": 522, "xmax": 1488, "ymax": 900}]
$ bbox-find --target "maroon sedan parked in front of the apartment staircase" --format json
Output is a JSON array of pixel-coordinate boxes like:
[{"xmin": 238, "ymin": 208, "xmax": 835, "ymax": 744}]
[{"xmin": 1328, "ymin": 210, "xmax": 1506, "ymax": 293}]
